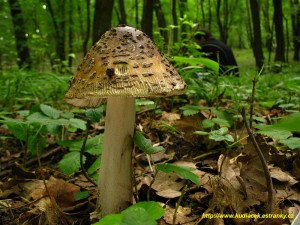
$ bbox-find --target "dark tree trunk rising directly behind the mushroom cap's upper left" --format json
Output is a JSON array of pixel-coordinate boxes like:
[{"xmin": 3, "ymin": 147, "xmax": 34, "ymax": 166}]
[{"xmin": 93, "ymin": 0, "xmax": 114, "ymax": 44}]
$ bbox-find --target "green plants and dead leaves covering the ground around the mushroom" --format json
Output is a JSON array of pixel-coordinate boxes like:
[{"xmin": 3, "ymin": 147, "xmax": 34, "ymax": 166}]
[{"xmin": 0, "ymin": 52, "xmax": 300, "ymax": 225}]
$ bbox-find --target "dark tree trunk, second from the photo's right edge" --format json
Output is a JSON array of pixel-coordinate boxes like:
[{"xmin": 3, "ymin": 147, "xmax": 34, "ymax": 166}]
[{"xmin": 273, "ymin": 0, "xmax": 285, "ymax": 62}]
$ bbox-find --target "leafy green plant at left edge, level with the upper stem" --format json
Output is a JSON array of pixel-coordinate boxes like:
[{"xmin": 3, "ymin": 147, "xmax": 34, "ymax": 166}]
[{"xmin": 0, "ymin": 104, "xmax": 86, "ymax": 155}]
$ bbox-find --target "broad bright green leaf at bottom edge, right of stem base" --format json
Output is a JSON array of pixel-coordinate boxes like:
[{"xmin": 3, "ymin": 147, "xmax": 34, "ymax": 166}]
[{"xmin": 120, "ymin": 207, "xmax": 157, "ymax": 225}]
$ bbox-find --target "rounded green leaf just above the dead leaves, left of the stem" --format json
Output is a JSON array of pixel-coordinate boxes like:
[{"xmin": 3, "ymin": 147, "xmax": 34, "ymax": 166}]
[{"xmin": 58, "ymin": 152, "xmax": 86, "ymax": 175}]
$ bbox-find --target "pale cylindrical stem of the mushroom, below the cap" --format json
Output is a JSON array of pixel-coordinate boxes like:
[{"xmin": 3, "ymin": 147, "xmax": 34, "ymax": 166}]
[{"xmin": 96, "ymin": 97, "xmax": 135, "ymax": 218}]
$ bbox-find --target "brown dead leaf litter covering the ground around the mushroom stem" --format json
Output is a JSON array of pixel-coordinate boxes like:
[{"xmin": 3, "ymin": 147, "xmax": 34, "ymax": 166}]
[{"xmin": 0, "ymin": 51, "xmax": 300, "ymax": 225}]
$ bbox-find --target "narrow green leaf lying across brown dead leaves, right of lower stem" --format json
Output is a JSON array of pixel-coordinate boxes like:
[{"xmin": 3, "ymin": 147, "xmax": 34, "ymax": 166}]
[{"xmin": 156, "ymin": 163, "xmax": 200, "ymax": 186}]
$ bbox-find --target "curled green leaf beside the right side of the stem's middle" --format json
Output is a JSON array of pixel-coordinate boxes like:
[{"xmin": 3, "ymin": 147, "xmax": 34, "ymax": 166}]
[{"xmin": 134, "ymin": 131, "xmax": 164, "ymax": 155}]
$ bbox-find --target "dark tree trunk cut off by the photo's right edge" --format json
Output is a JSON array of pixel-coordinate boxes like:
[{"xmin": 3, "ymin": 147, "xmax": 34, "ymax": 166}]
[{"xmin": 290, "ymin": 0, "xmax": 300, "ymax": 61}]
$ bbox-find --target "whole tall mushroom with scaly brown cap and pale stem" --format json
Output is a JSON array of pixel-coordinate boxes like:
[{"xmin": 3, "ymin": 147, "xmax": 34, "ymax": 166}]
[{"xmin": 65, "ymin": 25, "xmax": 186, "ymax": 218}]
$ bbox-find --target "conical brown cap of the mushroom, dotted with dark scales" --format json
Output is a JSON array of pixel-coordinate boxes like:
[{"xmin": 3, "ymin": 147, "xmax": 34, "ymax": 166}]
[{"xmin": 65, "ymin": 25, "xmax": 186, "ymax": 107}]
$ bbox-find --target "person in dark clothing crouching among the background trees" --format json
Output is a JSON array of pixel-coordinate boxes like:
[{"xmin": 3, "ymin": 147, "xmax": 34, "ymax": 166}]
[{"xmin": 195, "ymin": 29, "xmax": 239, "ymax": 76}]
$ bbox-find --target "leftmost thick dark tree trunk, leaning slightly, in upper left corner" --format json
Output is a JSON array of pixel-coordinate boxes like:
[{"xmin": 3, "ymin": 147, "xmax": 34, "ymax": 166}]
[{"xmin": 8, "ymin": 0, "xmax": 31, "ymax": 69}]
